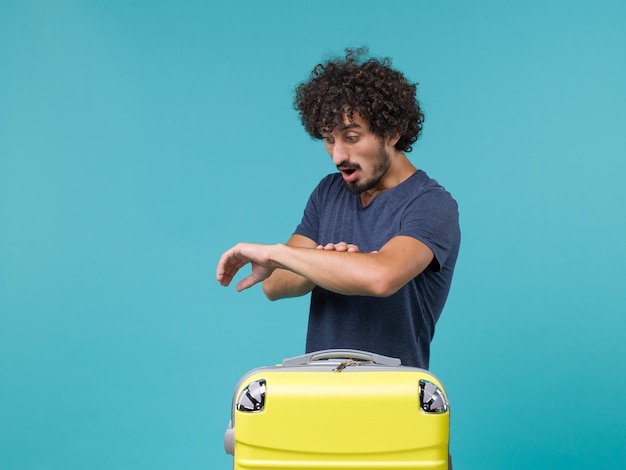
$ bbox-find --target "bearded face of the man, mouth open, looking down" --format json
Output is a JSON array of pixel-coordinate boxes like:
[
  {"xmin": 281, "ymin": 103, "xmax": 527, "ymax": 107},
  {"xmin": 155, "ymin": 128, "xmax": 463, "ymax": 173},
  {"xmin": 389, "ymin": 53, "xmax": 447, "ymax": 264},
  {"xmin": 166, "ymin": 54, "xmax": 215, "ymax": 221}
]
[{"xmin": 322, "ymin": 113, "xmax": 391, "ymax": 194}]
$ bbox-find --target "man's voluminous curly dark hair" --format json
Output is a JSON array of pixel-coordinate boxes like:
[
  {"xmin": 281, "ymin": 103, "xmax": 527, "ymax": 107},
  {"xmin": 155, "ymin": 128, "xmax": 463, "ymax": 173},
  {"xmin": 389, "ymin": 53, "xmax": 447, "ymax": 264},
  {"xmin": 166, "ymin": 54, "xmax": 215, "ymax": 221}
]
[{"xmin": 293, "ymin": 47, "xmax": 424, "ymax": 152}]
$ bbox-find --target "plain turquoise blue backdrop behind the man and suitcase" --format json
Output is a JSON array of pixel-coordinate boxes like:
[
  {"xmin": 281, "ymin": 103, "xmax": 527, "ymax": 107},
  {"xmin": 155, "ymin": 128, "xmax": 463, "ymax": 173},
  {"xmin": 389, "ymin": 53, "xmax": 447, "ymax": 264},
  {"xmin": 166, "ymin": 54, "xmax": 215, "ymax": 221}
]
[{"xmin": 0, "ymin": 0, "xmax": 626, "ymax": 470}]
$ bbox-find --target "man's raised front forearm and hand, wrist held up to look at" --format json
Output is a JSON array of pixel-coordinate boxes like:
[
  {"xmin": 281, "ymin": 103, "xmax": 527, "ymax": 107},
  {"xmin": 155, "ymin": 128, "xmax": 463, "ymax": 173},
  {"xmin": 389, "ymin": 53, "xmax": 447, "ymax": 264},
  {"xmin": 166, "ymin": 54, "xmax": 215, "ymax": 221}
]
[{"xmin": 217, "ymin": 236, "xmax": 433, "ymax": 297}]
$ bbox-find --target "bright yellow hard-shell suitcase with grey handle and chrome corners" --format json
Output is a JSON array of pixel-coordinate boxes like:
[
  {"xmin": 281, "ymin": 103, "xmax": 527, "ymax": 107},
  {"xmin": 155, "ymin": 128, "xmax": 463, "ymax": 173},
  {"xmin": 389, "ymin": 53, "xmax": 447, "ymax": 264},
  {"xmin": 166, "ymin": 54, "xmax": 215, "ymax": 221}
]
[{"xmin": 224, "ymin": 350, "xmax": 452, "ymax": 470}]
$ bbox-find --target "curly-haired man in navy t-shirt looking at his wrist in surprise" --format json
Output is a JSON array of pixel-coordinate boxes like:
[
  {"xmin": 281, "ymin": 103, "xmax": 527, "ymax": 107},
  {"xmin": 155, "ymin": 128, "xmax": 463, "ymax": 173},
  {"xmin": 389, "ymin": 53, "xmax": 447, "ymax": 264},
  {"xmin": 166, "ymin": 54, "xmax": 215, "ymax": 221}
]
[{"xmin": 217, "ymin": 49, "xmax": 460, "ymax": 369}]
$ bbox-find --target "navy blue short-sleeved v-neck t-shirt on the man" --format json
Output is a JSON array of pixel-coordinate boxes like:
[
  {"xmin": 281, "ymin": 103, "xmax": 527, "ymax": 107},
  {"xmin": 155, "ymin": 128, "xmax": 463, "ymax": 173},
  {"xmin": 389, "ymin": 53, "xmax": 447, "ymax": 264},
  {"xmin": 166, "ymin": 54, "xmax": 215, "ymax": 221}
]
[{"xmin": 295, "ymin": 170, "xmax": 460, "ymax": 369}]
